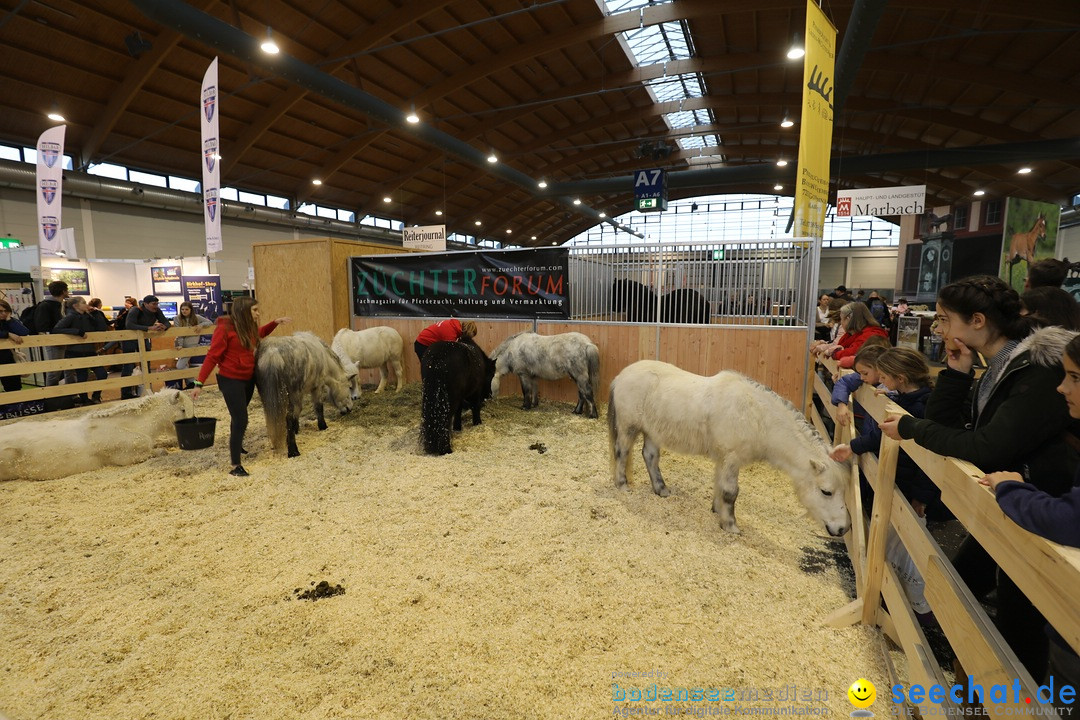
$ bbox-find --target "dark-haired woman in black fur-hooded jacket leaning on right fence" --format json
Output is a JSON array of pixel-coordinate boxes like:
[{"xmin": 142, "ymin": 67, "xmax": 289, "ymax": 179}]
[{"xmin": 881, "ymin": 275, "xmax": 1076, "ymax": 678}]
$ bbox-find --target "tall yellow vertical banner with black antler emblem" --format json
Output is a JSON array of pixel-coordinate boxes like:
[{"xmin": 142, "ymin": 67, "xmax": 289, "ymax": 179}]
[{"xmin": 793, "ymin": 0, "xmax": 836, "ymax": 237}]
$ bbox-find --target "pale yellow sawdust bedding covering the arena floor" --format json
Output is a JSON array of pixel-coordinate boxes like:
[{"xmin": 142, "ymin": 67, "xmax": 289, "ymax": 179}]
[{"xmin": 0, "ymin": 383, "xmax": 886, "ymax": 720}]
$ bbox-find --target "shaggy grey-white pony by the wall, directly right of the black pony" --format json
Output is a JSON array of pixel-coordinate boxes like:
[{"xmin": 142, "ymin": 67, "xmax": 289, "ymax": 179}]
[{"xmin": 491, "ymin": 331, "xmax": 600, "ymax": 418}]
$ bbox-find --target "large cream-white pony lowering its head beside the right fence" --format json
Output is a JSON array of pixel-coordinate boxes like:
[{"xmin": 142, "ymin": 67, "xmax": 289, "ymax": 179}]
[{"xmin": 608, "ymin": 361, "xmax": 851, "ymax": 536}]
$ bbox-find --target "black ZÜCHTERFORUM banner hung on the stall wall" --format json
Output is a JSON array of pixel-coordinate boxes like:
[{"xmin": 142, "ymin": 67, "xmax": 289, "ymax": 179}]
[{"xmin": 350, "ymin": 247, "xmax": 570, "ymax": 320}]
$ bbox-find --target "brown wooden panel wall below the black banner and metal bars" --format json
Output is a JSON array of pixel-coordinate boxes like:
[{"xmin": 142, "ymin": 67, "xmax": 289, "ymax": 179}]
[{"xmin": 352, "ymin": 317, "xmax": 807, "ymax": 407}]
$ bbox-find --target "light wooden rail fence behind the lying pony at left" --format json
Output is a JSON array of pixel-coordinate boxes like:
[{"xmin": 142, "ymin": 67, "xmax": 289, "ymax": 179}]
[{"xmin": 0, "ymin": 326, "xmax": 214, "ymax": 405}]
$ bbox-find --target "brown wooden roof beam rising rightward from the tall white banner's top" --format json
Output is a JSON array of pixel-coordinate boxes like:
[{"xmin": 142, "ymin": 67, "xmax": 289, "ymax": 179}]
[{"xmin": 221, "ymin": 0, "xmax": 450, "ymax": 175}]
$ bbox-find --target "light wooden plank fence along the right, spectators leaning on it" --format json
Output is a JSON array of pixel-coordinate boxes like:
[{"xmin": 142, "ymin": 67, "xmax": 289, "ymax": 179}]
[{"xmin": 807, "ymin": 359, "xmax": 1080, "ymax": 717}]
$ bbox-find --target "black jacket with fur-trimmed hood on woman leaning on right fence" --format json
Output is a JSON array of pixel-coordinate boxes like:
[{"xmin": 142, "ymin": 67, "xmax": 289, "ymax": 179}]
[{"xmin": 899, "ymin": 327, "xmax": 1077, "ymax": 497}]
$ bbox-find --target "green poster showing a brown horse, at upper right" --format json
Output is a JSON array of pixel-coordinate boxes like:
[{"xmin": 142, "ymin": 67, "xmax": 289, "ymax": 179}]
[{"xmin": 999, "ymin": 198, "xmax": 1062, "ymax": 293}]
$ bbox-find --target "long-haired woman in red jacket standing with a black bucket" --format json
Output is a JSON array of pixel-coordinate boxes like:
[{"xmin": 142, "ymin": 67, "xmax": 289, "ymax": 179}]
[{"xmin": 191, "ymin": 297, "xmax": 292, "ymax": 477}]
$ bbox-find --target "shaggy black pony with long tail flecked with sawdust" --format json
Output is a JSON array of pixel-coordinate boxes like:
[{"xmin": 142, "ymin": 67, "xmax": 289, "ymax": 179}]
[{"xmin": 420, "ymin": 339, "xmax": 495, "ymax": 456}]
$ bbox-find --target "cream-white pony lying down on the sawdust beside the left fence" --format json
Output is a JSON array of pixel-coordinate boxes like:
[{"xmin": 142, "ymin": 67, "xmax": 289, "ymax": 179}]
[{"xmin": 0, "ymin": 389, "xmax": 194, "ymax": 480}]
